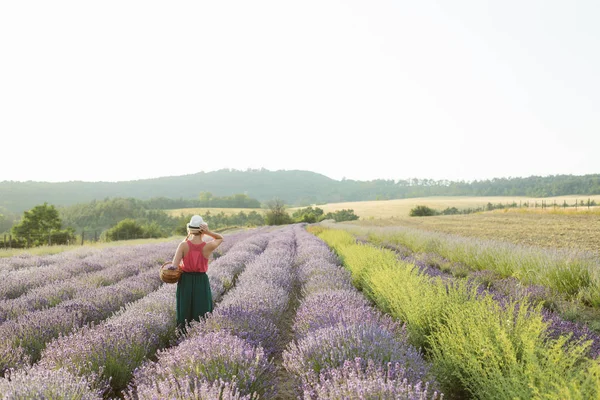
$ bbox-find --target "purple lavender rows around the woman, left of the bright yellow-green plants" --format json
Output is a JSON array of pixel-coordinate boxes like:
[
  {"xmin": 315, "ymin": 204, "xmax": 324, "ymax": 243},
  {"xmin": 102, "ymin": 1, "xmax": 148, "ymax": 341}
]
[{"xmin": 0, "ymin": 225, "xmax": 442, "ymax": 400}]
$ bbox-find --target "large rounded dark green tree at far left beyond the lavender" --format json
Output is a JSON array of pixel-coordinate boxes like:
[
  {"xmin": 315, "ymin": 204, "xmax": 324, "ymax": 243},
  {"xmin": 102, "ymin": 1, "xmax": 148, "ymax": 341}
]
[{"xmin": 12, "ymin": 203, "xmax": 74, "ymax": 246}]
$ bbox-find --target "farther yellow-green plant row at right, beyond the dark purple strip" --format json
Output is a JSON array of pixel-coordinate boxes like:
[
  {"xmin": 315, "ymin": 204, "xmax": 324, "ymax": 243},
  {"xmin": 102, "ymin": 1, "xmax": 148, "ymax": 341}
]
[{"xmin": 344, "ymin": 227, "xmax": 600, "ymax": 307}]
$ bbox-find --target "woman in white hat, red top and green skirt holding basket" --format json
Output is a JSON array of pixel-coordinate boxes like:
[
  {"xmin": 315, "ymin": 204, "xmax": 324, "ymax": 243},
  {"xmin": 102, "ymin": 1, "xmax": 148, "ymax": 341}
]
[{"xmin": 173, "ymin": 215, "xmax": 223, "ymax": 333}]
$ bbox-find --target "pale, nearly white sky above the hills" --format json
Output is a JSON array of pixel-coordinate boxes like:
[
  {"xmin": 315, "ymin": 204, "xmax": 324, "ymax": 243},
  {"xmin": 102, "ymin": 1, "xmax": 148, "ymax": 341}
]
[{"xmin": 0, "ymin": 0, "xmax": 600, "ymax": 181}]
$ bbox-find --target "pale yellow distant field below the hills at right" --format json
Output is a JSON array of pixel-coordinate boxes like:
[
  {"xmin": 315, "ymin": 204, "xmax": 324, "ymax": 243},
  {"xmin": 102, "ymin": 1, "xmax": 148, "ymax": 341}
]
[{"xmin": 296, "ymin": 196, "xmax": 600, "ymax": 219}]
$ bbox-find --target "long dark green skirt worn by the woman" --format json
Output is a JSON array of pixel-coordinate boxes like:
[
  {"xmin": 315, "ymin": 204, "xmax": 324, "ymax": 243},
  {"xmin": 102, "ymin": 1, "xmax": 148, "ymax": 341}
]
[{"xmin": 177, "ymin": 272, "xmax": 213, "ymax": 332}]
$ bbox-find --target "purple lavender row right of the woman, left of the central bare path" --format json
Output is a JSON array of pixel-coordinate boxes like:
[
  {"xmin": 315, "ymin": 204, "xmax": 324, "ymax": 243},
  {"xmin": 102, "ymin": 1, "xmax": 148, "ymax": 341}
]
[{"xmin": 127, "ymin": 228, "xmax": 295, "ymax": 400}]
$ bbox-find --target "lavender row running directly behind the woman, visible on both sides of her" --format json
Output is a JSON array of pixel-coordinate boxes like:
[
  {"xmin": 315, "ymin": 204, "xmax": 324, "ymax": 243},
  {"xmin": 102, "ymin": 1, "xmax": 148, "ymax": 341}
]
[{"xmin": 28, "ymin": 231, "xmax": 268, "ymax": 391}]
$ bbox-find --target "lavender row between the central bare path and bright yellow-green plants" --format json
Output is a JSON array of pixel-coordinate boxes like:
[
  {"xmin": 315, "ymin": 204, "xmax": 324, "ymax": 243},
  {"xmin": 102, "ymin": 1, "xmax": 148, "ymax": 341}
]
[{"xmin": 283, "ymin": 228, "xmax": 442, "ymax": 400}]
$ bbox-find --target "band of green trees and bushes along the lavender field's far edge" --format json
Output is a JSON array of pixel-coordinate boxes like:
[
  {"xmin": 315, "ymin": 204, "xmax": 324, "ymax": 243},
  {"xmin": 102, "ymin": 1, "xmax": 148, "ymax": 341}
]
[{"xmin": 0, "ymin": 198, "xmax": 358, "ymax": 248}]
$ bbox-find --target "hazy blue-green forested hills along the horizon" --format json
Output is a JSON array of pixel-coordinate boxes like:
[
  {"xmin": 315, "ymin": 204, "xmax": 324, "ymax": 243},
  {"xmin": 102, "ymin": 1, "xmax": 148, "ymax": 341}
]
[{"xmin": 0, "ymin": 169, "xmax": 600, "ymax": 215}]
